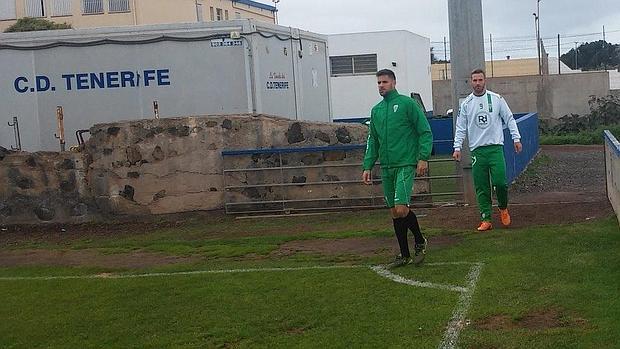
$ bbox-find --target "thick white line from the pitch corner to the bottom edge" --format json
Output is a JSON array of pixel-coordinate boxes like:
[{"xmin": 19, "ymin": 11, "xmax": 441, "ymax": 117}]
[{"xmin": 438, "ymin": 263, "xmax": 482, "ymax": 349}]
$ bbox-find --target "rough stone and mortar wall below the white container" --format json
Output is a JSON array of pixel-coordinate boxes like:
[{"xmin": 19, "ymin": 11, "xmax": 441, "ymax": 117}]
[{"xmin": 0, "ymin": 115, "xmax": 367, "ymax": 224}]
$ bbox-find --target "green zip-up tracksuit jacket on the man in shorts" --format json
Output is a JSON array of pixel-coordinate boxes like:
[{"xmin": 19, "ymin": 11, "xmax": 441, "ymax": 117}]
[{"xmin": 363, "ymin": 90, "xmax": 433, "ymax": 170}]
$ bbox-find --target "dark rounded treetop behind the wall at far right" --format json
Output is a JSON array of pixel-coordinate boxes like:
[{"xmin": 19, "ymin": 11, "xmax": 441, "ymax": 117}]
[{"xmin": 560, "ymin": 40, "xmax": 620, "ymax": 70}]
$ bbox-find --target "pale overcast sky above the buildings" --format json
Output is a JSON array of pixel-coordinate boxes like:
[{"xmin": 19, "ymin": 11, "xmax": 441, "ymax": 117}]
[{"xmin": 278, "ymin": 0, "xmax": 620, "ymax": 58}]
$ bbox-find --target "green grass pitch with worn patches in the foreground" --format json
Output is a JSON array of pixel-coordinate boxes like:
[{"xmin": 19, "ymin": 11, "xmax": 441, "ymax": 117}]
[{"xmin": 0, "ymin": 211, "xmax": 620, "ymax": 348}]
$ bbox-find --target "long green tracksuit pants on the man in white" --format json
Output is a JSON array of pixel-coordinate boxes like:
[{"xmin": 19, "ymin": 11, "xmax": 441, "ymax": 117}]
[{"xmin": 471, "ymin": 145, "xmax": 508, "ymax": 222}]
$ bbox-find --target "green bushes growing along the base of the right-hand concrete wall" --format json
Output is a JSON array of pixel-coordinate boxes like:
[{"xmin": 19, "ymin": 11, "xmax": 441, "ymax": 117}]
[{"xmin": 540, "ymin": 96, "xmax": 620, "ymax": 144}]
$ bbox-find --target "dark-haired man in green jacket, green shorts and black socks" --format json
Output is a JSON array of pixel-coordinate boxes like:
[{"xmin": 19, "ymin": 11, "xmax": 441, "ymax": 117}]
[{"xmin": 362, "ymin": 69, "xmax": 433, "ymax": 267}]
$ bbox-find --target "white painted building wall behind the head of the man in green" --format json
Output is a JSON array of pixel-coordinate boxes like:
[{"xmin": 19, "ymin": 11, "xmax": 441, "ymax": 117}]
[{"xmin": 328, "ymin": 30, "xmax": 433, "ymax": 119}]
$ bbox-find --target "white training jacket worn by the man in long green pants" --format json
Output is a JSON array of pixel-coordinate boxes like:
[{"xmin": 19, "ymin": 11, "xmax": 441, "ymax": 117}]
[{"xmin": 454, "ymin": 91, "xmax": 521, "ymax": 151}]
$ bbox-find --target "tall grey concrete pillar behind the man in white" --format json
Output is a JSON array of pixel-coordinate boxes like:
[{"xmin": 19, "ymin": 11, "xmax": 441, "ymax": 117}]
[{"xmin": 448, "ymin": 0, "xmax": 485, "ymax": 204}]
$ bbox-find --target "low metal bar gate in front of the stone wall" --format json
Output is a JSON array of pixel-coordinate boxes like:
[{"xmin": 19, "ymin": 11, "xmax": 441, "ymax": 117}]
[{"xmin": 222, "ymin": 144, "xmax": 463, "ymax": 214}]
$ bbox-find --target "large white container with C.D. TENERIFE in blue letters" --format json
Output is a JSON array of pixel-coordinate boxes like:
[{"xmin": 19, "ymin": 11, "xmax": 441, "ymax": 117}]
[{"xmin": 0, "ymin": 20, "xmax": 331, "ymax": 151}]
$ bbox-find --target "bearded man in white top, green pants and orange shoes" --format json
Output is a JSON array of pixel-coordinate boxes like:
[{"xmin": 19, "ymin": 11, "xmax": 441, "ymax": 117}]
[{"xmin": 452, "ymin": 69, "xmax": 522, "ymax": 231}]
